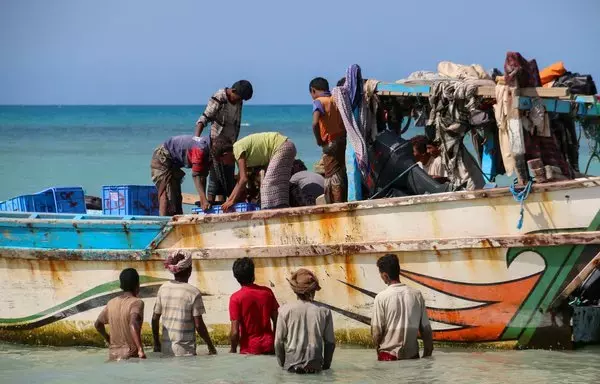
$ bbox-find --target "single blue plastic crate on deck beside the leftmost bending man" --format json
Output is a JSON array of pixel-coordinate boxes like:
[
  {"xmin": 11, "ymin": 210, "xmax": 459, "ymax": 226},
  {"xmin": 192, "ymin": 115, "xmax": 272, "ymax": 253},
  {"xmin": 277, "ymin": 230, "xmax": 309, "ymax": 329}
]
[{"xmin": 102, "ymin": 185, "xmax": 158, "ymax": 216}]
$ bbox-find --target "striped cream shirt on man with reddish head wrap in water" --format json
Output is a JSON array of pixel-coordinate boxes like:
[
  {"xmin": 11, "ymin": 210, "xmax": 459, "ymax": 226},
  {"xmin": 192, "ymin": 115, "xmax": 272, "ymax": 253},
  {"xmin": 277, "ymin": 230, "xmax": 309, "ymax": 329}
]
[{"xmin": 154, "ymin": 280, "xmax": 206, "ymax": 356}]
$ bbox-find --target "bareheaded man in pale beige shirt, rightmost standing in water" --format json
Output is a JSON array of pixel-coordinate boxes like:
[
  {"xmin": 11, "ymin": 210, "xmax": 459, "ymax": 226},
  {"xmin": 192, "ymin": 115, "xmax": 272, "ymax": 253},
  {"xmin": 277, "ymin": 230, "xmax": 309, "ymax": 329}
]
[{"xmin": 371, "ymin": 254, "xmax": 433, "ymax": 361}]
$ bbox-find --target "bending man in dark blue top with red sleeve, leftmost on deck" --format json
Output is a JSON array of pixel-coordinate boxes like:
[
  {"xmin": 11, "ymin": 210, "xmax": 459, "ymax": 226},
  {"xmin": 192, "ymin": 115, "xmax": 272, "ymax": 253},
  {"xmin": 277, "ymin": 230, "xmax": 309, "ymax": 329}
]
[{"xmin": 150, "ymin": 135, "xmax": 211, "ymax": 216}]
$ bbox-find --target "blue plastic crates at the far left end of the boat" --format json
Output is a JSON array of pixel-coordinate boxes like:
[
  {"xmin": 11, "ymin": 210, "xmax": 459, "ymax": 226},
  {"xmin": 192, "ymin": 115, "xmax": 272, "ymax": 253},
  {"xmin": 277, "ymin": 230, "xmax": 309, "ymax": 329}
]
[{"xmin": 0, "ymin": 187, "xmax": 86, "ymax": 213}]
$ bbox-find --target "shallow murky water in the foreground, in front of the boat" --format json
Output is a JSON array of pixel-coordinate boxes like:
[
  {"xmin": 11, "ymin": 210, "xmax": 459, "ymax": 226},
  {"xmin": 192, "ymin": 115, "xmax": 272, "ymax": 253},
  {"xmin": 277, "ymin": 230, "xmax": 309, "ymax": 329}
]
[{"xmin": 0, "ymin": 344, "xmax": 600, "ymax": 384}]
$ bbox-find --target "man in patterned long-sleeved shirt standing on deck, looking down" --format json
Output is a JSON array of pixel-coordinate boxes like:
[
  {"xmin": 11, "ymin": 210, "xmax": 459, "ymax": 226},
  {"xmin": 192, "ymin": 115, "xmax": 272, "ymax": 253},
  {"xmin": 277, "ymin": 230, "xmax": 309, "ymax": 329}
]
[{"xmin": 195, "ymin": 80, "xmax": 253, "ymax": 201}]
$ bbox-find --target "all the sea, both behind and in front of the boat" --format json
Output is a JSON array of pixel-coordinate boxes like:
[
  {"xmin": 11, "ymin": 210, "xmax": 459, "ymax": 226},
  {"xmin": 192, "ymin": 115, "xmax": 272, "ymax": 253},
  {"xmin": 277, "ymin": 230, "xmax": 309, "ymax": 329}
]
[{"xmin": 0, "ymin": 105, "xmax": 600, "ymax": 384}]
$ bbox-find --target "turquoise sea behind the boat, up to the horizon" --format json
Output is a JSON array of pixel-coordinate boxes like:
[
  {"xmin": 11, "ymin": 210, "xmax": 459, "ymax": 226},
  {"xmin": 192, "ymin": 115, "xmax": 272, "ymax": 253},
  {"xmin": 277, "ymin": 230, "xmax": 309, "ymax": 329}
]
[{"xmin": 0, "ymin": 105, "xmax": 600, "ymax": 200}]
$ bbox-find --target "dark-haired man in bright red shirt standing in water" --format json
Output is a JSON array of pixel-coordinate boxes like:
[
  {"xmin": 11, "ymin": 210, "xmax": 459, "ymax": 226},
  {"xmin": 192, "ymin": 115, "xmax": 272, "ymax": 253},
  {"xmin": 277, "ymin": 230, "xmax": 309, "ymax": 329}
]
[{"xmin": 229, "ymin": 257, "xmax": 279, "ymax": 355}]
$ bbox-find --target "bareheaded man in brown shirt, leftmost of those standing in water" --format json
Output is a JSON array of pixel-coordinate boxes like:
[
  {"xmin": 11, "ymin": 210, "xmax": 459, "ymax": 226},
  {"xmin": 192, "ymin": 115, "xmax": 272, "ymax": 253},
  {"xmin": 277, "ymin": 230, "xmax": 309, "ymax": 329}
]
[{"xmin": 94, "ymin": 268, "xmax": 146, "ymax": 360}]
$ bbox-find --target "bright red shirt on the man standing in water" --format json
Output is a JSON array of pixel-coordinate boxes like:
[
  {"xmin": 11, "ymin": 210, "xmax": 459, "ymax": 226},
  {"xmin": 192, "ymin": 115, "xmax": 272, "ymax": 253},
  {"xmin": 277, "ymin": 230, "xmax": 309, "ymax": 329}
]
[{"xmin": 229, "ymin": 284, "xmax": 279, "ymax": 355}]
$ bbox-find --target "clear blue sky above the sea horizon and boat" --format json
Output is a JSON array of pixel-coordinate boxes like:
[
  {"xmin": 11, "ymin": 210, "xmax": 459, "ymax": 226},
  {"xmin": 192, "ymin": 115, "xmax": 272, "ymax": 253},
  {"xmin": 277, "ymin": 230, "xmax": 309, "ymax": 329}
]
[{"xmin": 0, "ymin": 0, "xmax": 600, "ymax": 104}]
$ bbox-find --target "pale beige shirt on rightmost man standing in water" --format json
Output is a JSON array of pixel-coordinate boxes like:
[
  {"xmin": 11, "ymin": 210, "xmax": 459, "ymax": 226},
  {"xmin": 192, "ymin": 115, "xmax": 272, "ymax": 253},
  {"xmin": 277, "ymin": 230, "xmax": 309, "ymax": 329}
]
[{"xmin": 371, "ymin": 284, "xmax": 429, "ymax": 359}]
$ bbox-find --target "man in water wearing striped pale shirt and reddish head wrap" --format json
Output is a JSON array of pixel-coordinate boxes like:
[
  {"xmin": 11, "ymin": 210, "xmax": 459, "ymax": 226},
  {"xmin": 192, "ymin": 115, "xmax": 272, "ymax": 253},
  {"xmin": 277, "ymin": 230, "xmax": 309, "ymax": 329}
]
[{"xmin": 152, "ymin": 251, "xmax": 217, "ymax": 356}]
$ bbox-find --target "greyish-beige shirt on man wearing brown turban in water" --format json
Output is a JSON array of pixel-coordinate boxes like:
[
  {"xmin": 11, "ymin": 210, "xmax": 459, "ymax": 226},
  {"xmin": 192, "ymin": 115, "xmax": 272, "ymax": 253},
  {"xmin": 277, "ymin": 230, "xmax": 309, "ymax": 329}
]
[{"xmin": 275, "ymin": 300, "xmax": 335, "ymax": 371}]
